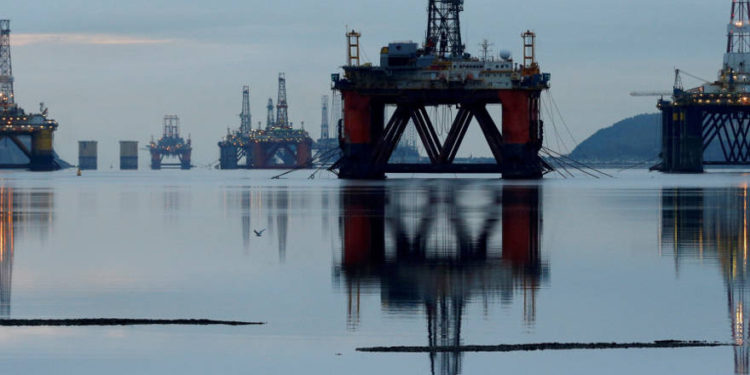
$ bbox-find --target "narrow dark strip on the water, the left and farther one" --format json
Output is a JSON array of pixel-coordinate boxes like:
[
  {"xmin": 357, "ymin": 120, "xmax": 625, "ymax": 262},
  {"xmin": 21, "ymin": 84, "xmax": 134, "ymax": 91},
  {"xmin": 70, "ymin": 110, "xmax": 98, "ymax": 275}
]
[{"xmin": 0, "ymin": 318, "xmax": 266, "ymax": 327}]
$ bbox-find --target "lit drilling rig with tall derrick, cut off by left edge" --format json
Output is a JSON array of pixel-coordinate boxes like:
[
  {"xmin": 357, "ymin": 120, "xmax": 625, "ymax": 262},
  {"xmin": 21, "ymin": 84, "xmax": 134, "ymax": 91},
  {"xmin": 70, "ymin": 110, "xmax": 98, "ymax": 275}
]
[{"xmin": 0, "ymin": 20, "xmax": 60, "ymax": 171}]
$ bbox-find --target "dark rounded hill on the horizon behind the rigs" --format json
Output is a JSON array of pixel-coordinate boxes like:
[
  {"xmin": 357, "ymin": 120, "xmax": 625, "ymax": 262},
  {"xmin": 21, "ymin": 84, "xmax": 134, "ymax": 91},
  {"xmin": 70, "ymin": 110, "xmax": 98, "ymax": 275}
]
[{"xmin": 569, "ymin": 113, "xmax": 661, "ymax": 163}]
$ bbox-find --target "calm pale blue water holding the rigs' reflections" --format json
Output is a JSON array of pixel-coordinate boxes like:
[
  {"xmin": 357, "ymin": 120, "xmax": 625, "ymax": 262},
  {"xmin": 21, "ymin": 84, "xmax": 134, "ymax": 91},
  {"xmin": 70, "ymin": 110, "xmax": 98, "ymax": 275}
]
[{"xmin": 0, "ymin": 170, "xmax": 750, "ymax": 374}]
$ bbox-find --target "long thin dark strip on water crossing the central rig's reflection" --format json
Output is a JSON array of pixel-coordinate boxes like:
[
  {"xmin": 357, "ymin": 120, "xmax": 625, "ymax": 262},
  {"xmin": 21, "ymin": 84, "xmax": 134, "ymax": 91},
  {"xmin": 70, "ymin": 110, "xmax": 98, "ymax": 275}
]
[{"xmin": 357, "ymin": 340, "xmax": 734, "ymax": 353}]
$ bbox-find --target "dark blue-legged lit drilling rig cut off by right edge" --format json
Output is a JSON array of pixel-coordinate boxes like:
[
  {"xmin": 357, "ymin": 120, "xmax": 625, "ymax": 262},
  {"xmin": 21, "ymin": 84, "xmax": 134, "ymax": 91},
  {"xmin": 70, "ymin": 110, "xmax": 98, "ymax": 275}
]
[{"xmin": 652, "ymin": 0, "xmax": 750, "ymax": 173}]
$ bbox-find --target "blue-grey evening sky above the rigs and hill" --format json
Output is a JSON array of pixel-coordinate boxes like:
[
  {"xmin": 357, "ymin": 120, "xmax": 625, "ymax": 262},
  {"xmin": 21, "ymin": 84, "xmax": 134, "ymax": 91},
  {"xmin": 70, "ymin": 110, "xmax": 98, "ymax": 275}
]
[{"xmin": 0, "ymin": 0, "xmax": 730, "ymax": 166}]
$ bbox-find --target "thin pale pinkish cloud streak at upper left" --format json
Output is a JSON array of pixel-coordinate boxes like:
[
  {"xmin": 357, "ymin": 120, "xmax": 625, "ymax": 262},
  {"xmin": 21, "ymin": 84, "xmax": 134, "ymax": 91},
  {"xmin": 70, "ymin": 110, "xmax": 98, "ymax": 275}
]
[{"xmin": 11, "ymin": 33, "xmax": 173, "ymax": 46}]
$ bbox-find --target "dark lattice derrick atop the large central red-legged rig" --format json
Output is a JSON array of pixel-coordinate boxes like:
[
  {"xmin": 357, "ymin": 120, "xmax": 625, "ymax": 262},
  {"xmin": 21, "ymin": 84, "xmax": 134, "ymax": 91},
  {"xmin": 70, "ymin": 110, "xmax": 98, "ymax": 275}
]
[{"xmin": 425, "ymin": 0, "xmax": 466, "ymax": 57}]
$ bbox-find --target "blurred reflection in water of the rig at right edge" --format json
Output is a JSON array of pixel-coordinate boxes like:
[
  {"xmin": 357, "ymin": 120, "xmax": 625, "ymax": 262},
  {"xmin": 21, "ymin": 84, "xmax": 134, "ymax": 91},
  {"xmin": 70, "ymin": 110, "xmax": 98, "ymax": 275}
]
[{"xmin": 661, "ymin": 187, "xmax": 750, "ymax": 374}]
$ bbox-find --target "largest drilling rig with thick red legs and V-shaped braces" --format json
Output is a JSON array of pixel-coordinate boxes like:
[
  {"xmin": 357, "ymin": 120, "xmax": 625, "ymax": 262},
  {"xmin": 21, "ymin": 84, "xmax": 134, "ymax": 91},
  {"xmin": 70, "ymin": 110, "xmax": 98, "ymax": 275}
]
[{"xmin": 332, "ymin": 0, "xmax": 551, "ymax": 179}]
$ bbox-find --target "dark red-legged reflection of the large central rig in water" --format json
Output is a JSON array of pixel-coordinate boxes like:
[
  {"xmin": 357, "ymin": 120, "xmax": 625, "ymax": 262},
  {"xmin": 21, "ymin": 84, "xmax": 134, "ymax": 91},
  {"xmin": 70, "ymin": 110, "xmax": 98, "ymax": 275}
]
[{"xmin": 336, "ymin": 181, "xmax": 548, "ymax": 374}]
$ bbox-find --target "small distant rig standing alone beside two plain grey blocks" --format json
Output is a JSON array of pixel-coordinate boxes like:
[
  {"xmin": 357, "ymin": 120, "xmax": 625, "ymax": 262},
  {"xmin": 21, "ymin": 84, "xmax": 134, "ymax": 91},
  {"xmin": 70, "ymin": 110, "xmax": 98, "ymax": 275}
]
[{"xmin": 148, "ymin": 115, "xmax": 193, "ymax": 169}]
